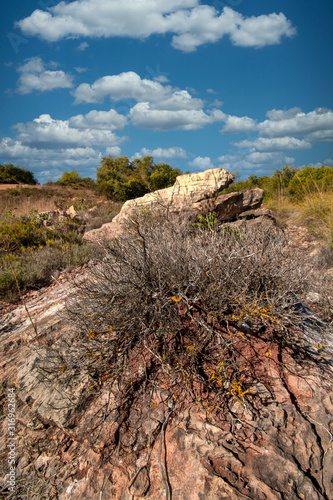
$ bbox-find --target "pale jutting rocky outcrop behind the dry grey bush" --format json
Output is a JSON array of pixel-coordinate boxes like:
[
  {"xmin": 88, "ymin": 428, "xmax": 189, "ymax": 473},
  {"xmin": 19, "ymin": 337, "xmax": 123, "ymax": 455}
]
[{"xmin": 84, "ymin": 168, "xmax": 264, "ymax": 241}]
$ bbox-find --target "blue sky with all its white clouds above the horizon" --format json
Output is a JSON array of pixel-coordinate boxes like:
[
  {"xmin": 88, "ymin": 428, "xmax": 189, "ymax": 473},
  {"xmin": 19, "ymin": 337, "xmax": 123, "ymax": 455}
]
[{"xmin": 0, "ymin": 0, "xmax": 333, "ymax": 183}]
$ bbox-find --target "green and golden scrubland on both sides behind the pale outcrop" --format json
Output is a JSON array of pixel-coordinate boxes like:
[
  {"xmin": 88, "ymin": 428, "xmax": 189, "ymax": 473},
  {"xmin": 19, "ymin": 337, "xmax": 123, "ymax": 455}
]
[{"xmin": 0, "ymin": 157, "xmax": 333, "ymax": 301}]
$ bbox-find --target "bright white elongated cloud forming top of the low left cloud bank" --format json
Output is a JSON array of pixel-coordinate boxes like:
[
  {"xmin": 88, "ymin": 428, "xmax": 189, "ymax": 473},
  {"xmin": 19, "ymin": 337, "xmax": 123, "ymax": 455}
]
[{"xmin": 14, "ymin": 114, "xmax": 124, "ymax": 149}]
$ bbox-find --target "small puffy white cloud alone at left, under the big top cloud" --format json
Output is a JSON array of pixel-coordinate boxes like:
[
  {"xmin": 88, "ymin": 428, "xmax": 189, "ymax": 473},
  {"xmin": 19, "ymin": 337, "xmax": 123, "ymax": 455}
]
[{"xmin": 17, "ymin": 57, "xmax": 73, "ymax": 94}]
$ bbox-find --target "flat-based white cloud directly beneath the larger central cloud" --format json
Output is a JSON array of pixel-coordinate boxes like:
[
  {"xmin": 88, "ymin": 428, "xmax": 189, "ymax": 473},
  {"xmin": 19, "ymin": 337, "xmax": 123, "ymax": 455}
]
[{"xmin": 129, "ymin": 102, "xmax": 225, "ymax": 130}]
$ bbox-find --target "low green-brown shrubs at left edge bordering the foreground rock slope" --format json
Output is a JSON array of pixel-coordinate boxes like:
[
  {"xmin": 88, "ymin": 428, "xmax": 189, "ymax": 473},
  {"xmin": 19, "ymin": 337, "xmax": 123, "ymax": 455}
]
[{"xmin": 0, "ymin": 213, "xmax": 90, "ymax": 300}]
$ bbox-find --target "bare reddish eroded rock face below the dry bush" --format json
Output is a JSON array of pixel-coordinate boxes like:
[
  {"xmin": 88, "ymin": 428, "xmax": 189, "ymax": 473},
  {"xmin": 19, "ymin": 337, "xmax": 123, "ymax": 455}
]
[{"xmin": 0, "ymin": 272, "xmax": 333, "ymax": 500}]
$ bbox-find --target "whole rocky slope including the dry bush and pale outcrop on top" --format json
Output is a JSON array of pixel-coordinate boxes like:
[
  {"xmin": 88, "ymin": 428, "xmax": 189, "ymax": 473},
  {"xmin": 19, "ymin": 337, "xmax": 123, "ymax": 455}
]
[{"xmin": 0, "ymin": 169, "xmax": 333, "ymax": 500}]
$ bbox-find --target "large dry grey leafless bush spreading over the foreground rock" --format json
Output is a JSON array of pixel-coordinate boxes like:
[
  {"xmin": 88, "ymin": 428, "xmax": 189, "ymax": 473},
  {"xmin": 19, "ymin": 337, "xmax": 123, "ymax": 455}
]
[{"xmin": 35, "ymin": 214, "xmax": 330, "ymax": 430}]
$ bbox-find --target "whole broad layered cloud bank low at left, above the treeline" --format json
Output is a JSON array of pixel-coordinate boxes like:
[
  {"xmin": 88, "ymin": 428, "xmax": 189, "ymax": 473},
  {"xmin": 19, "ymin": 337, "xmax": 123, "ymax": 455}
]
[{"xmin": 0, "ymin": 109, "xmax": 127, "ymax": 182}]
